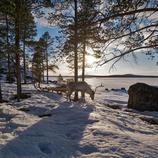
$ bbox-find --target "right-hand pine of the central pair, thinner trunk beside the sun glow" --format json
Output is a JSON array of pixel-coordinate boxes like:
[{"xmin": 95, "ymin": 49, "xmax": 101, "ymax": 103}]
[{"xmin": 79, "ymin": 0, "xmax": 105, "ymax": 81}]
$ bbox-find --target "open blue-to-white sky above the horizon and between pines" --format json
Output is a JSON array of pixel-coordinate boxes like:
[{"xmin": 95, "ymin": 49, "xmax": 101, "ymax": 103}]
[{"xmin": 36, "ymin": 20, "xmax": 158, "ymax": 75}]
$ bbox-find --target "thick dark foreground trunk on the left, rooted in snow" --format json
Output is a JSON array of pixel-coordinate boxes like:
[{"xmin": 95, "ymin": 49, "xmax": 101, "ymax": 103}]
[{"xmin": 15, "ymin": 0, "xmax": 21, "ymax": 101}]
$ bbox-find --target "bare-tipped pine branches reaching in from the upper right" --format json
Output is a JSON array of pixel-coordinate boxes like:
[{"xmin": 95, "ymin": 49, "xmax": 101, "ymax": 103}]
[{"xmin": 95, "ymin": 0, "xmax": 158, "ymax": 68}]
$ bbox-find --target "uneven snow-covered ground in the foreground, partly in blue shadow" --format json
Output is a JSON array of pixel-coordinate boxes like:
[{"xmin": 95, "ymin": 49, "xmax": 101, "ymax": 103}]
[{"xmin": 0, "ymin": 84, "xmax": 158, "ymax": 158}]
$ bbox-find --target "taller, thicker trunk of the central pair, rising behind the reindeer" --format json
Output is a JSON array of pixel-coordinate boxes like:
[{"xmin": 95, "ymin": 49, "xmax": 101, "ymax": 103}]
[{"xmin": 74, "ymin": 0, "xmax": 78, "ymax": 101}]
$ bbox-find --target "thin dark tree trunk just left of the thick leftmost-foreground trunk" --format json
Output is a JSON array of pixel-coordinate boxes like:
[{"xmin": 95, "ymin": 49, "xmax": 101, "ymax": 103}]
[{"xmin": 6, "ymin": 14, "xmax": 11, "ymax": 83}]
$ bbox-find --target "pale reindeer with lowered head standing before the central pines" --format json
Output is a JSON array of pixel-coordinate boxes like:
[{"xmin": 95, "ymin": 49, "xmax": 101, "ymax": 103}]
[{"xmin": 66, "ymin": 81, "xmax": 102, "ymax": 101}]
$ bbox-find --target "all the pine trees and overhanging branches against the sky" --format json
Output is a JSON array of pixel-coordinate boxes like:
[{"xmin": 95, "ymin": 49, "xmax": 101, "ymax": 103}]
[{"xmin": 0, "ymin": 0, "xmax": 158, "ymax": 99}]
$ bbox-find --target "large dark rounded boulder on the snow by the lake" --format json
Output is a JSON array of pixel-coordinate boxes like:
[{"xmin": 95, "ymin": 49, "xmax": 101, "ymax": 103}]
[{"xmin": 128, "ymin": 83, "xmax": 158, "ymax": 111}]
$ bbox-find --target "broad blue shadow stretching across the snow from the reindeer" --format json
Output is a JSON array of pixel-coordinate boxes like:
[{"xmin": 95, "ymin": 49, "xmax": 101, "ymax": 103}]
[{"xmin": 0, "ymin": 102, "xmax": 97, "ymax": 158}]
